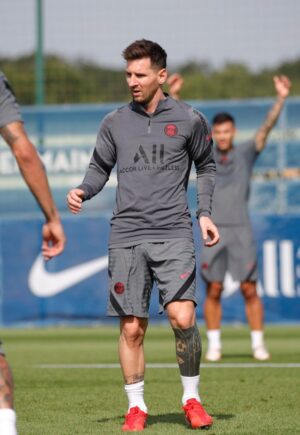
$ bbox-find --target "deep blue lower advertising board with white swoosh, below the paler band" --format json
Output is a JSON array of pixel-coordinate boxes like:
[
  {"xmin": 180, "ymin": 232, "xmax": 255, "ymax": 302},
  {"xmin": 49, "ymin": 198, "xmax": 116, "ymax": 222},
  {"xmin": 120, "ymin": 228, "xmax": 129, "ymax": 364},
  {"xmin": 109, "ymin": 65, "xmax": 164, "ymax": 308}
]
[{"xmin": 0, "ymin": 216, "xmax": 300, "ymax": 325}]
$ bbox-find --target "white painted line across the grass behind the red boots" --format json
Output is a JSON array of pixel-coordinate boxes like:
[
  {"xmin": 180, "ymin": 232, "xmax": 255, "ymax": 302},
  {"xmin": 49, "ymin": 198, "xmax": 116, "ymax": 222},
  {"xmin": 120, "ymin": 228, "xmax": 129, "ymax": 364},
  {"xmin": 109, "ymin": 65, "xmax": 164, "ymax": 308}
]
[{"xmin": 34, "ymin": 363, "xmax": 300, "ymax": 369}]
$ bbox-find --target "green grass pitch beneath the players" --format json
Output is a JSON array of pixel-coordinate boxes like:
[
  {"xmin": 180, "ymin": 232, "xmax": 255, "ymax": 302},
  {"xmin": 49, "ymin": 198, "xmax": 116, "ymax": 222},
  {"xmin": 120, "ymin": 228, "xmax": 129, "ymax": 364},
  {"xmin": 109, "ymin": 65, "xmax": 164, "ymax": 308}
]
[{"xmin": 0, "ymin": 324, "xmax": 300, "ymax": 435}]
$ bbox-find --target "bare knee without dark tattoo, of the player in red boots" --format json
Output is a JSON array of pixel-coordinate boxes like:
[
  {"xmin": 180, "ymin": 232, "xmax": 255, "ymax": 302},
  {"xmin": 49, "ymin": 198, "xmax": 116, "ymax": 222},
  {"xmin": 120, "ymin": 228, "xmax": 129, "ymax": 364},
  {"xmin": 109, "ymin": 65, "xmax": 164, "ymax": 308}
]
[{"xmin": 120, "ymin": 316, "xmax": 148, "ymax": 347}]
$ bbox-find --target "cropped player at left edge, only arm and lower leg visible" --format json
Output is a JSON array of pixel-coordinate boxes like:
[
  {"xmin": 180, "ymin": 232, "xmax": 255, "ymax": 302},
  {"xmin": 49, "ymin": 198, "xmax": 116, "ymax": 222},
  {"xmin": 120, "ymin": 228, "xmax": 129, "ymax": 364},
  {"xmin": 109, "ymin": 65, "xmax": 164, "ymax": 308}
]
[{"xmin": 0, "ymin": 71, "xmax": 65, "ymax": 435}]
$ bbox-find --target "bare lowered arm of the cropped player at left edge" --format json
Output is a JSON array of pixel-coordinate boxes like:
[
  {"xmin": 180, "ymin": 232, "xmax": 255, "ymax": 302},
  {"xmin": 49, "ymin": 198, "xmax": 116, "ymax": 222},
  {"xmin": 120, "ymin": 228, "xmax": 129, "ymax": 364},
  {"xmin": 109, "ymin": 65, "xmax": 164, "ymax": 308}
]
[{"xmin": 0, "ymin": 121, "xmax": 65, "ymax": 260}]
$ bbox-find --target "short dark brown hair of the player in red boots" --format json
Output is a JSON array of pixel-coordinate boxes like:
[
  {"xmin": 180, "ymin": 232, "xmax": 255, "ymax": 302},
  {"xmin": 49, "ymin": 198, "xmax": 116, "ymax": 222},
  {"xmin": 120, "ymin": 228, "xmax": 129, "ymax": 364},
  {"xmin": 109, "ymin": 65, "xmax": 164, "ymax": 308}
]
[{"xmin": 122, "ymin": 39, "xmax": 167, "ymax": 68}]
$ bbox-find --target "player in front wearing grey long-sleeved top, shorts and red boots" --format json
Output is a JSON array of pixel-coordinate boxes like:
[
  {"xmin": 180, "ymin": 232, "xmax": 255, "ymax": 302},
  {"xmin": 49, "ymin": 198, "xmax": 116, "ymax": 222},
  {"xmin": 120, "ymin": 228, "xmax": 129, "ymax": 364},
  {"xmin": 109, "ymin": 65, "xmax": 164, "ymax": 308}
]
[{"xmin": 67, "ymin": 40, "xmax": 218, "ymax": 431}]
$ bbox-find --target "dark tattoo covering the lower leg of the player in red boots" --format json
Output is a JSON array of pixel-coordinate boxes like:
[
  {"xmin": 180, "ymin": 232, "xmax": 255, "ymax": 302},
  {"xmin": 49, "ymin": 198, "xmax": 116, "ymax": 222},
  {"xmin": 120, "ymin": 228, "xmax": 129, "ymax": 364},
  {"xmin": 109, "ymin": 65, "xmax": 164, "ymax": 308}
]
[{"xmin": 173, "ymin": 324, "xmax": 202, "ymax": 376}]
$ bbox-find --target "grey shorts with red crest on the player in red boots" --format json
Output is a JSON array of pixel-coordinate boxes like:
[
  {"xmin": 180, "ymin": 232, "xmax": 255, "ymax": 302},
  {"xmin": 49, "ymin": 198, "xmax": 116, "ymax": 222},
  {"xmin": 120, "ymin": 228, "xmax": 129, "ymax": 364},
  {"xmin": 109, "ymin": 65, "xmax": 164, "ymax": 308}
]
[{"xmin": 108, "ymin": 239, "xmax": 196, "ymax": 318}]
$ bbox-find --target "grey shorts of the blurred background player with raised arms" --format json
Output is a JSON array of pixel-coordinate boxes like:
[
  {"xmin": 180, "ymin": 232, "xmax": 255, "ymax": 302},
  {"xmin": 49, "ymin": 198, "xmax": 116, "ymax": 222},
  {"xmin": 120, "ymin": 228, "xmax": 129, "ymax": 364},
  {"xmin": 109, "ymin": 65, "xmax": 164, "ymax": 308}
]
[{"xmin": 201, "ymin": 224, "xmax": 258, "ymax": 282}]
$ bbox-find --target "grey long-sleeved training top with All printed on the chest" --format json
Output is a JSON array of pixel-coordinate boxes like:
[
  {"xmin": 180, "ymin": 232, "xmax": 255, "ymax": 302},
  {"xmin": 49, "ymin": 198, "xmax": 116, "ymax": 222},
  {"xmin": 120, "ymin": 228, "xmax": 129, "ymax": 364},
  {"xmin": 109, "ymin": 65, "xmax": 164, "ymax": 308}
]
[{"xmin": 78, "ymin": 96, "xmax": 215, "ymax": 247}]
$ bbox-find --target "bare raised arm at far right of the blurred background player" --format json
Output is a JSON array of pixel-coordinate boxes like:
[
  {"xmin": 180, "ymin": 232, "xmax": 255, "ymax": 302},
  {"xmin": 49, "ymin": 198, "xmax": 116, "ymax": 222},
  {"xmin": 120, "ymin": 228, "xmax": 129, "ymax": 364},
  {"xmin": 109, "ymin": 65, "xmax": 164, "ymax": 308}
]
[{"xmin": 255, "ymin": 76, "xmax": 291, "ymax": 152}]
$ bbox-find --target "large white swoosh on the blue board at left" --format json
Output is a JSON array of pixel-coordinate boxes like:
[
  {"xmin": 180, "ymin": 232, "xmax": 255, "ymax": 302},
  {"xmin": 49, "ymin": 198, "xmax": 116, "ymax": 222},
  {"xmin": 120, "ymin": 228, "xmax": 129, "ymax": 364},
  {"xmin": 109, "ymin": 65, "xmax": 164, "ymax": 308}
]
[{"xmin": 28, "ymin": 256, "xmax": 108, "ymax": 298}]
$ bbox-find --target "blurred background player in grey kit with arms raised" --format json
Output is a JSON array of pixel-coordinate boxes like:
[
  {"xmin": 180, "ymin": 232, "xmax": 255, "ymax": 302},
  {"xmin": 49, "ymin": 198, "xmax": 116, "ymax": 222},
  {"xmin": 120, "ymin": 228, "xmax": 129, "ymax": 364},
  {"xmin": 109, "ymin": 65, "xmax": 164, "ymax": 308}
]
[{"xmin": 201, "ymin": 76, "xmax": 290, "ymax": 361}]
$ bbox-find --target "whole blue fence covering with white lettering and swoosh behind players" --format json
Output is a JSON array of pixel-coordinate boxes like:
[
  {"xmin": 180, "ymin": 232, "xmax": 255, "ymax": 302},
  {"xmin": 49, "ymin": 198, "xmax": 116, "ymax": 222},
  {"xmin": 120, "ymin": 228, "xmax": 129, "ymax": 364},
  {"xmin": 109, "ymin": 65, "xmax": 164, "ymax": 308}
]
[{"xmin": 0, "ymin": 98, "xmax": 300, "ymax": 326}]
